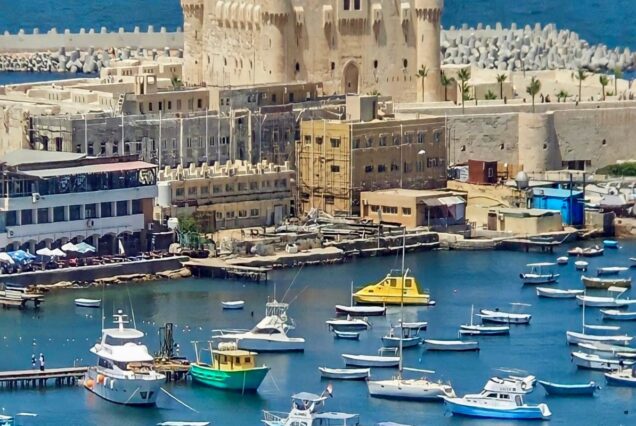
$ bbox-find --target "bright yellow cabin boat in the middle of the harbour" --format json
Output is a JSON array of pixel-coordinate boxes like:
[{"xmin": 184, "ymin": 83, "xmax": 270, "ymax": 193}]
[{"xmin": 353, "ymin": 271, "xmax": 435, "ymax": 305}]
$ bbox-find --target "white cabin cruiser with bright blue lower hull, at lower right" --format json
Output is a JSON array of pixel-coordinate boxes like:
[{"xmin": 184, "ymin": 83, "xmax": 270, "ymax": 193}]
[{"xmin": 442, "ymin": 377, "xmax": 552, "ymax": 420}]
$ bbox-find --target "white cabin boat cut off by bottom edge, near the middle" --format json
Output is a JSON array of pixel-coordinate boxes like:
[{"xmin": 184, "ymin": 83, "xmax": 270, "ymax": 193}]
[{"xmin": 262, "ymin": 384, "xmax": 360, "ymax": 426}]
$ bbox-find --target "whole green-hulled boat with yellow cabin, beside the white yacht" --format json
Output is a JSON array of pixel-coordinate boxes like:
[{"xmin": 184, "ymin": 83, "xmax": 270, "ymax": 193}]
[{"xmin": 189, "ymin": 342, "xmax": 270, "ymax": 393}]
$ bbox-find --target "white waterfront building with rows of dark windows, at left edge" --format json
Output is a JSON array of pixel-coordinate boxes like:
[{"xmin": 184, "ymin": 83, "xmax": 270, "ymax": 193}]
[{"xmin": 0, "ymin": 150, "xmax": 157, "ymax": 253}]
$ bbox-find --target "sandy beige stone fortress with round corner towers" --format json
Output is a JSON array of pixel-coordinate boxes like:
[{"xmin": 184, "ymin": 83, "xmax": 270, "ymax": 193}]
[{"xmin": 181, "ymin": 0, "xmax": 444, "ymax": 100}]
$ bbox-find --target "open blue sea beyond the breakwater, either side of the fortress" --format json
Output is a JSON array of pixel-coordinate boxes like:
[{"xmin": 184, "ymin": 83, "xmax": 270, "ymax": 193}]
[{"xmin": 0, "ymin": 0, "xmax": 636, "ymax": 49}]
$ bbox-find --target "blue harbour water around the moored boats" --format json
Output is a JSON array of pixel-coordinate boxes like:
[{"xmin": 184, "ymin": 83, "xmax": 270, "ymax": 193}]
[{"xmin": 0, "ymin": 241, "xmax": 636, "ymax": 426}]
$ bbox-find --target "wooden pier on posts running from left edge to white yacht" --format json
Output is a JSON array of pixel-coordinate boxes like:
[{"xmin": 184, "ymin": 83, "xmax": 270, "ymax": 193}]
[{"xmin": 0, "ymin": 367, "xmax": 88, "ymax": 389}]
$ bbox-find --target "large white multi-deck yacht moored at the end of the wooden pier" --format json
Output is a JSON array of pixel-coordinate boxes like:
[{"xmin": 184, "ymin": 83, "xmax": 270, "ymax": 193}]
[{"xmin": 84, "ymin": 310, "xmax": 166, "ymax": 406}]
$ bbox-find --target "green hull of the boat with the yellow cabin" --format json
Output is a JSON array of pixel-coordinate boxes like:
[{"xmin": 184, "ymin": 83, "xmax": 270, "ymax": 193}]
[{"xmin": 190, "ymin": 364, "xmax": 269, "ymax": 392}]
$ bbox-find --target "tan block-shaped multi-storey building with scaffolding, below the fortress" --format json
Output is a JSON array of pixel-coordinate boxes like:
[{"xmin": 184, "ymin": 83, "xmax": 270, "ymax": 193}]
[{"xmin": 296, "ymin": 96, "xmax": 446, "ymax": 215}]
